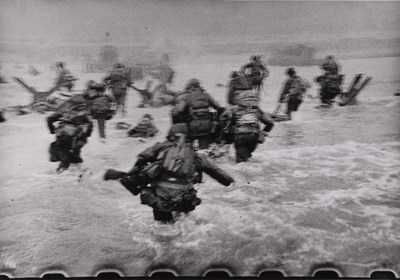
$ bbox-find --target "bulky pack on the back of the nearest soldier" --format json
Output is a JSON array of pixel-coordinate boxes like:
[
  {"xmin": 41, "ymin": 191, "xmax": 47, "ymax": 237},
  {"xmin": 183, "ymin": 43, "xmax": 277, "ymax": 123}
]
[{"xmin": 162, "ymin": 136, "xmax": 196, "ymax": 178}]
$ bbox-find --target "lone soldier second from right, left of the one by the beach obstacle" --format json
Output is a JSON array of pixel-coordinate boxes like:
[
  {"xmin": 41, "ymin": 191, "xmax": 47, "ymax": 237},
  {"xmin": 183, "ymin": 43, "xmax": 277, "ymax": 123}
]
[{"xmin": 275, "ymin": 67, "xmax": 310, "ymax": 120}]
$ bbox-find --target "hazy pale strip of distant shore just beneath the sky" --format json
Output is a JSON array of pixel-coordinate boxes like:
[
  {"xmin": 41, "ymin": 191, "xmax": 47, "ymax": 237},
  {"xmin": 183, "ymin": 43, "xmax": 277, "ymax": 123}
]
[{"xmin": 0, "ymin": 37, "xmax": 400, "ymax": 63}]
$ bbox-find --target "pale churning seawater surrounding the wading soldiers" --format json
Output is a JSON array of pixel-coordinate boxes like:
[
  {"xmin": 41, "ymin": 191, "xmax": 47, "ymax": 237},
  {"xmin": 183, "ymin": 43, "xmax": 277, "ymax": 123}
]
[{"xmin": 0, "ymin": 56, "xmax": 400, "ymax": 276}]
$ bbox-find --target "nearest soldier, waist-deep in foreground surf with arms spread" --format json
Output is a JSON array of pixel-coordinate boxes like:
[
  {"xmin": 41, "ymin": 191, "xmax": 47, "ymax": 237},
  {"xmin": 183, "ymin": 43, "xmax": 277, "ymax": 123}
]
[{"xmin": 104, "ymin": 124, "xmax": 234, "ymax": 223}]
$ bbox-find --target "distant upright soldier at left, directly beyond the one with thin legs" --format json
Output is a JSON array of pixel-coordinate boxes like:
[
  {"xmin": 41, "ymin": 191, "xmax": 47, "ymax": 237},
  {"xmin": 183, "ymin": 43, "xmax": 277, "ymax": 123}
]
[{"xmin": 104, "ymin": 63, "xmax": 132, "ymax": 116}]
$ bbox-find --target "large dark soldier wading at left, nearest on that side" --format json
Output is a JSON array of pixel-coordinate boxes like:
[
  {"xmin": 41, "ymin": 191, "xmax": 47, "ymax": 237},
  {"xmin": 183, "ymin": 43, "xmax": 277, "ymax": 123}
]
[{"xmin": 47, "ymin": 95, "xmax": 93, "ymax": 172}]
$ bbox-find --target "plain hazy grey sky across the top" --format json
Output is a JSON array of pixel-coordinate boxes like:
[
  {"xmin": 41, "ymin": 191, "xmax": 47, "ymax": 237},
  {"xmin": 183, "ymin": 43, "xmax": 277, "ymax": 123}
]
[{"xmin": 0, "ymin": 0, "xmax": 400, "ymax": 43}]
